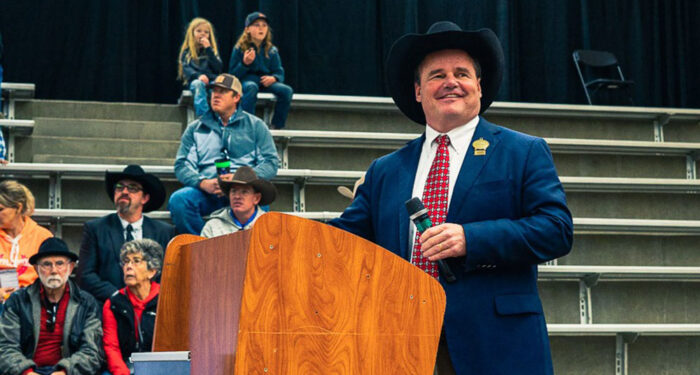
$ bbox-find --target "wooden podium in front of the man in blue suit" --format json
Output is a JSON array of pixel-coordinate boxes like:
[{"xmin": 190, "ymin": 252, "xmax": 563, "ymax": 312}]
[{"xmin": 153, "ymin": 212, "xmax": 445, "ymax": 375}]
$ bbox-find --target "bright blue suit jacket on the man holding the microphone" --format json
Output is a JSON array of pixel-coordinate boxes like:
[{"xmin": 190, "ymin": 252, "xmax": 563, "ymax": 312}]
[{"xmin": 331, "ymin": 118, "xmax": 573, "ymax": 375}]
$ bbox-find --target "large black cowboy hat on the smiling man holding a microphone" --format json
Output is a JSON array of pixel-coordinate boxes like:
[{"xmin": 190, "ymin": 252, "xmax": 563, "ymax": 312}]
[{"xmin": 386, "ymin": 21, "xmax": 504, "ymax": 125}]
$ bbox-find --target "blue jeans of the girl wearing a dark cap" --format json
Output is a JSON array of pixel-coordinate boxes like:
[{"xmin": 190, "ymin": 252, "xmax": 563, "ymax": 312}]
[{"xmin": 241, "ymin": 75, "xmax": 294, "ymax": 129}]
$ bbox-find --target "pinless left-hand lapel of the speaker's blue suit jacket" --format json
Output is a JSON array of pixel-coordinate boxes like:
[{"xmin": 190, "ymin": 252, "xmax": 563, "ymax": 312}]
[{"xmin": 397, "ymin": 133, "xmax": 425, "ymax": 260}]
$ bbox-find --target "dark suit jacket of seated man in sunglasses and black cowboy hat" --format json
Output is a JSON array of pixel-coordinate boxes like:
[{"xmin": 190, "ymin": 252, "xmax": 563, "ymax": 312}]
[{"xmin": 78, "ymin": 213, "xmax": 175, "ymax": 304}]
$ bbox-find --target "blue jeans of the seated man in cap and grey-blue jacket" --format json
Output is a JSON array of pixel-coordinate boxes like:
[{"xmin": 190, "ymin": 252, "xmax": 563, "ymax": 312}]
[{"xmin": 168, "ymin": 186, "xmax": 228, "ymax": 236}]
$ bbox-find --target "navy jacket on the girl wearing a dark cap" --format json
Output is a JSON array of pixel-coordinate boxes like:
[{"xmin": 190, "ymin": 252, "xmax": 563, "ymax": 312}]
[{"xmin": 228, "ymin": 45, "xmax": 284, "ymax": 83}]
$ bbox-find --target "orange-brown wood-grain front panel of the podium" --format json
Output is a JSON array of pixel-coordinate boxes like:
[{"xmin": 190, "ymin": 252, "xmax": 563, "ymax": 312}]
[{"xmin": 235, "ymin": 213, "xmax": 445, "ymax": 375}]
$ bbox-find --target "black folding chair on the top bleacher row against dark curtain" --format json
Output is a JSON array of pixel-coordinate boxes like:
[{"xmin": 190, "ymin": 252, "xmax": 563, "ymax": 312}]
[{"xmin": 573, "ymin": 49, "xmax": 634, "ymax": 105}]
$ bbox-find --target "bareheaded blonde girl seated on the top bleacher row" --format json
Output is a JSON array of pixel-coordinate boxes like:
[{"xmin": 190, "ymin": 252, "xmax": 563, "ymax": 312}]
[{"xmin": 178, "ymin": 18, "xmax": 223, "ymax": 117}]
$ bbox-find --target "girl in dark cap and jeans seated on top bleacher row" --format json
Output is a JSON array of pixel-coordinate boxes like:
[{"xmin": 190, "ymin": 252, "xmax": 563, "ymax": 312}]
[{"xmin": 228, "ymin": 12, "xmax": 293, "ymax": 129}]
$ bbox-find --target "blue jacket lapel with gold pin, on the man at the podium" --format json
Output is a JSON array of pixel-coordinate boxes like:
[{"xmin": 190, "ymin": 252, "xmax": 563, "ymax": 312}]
[{"xmin": 446, "ymin": 118, "xmax": 500, "ymax": 222}]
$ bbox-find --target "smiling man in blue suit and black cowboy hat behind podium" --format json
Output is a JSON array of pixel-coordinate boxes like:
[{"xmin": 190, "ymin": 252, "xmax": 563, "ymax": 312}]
[{"xmin": 332, "ymin": 22, "xmax": 573, "ymax": 375}]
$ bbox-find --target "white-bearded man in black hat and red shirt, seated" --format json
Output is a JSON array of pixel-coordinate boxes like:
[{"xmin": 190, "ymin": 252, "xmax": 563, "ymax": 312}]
[{"xmin": 0, "ymin": 237, "xmax": 102, "ymax": 375}]
